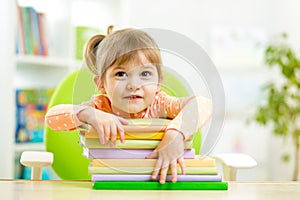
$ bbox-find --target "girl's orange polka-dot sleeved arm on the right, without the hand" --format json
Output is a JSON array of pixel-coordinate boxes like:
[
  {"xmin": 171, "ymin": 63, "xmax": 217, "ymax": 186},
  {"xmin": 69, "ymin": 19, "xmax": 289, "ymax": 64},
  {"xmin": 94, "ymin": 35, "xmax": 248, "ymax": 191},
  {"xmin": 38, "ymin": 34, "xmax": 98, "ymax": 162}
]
[{"xmin": 149, "ymin": 91, "xmax": 213, "ymax": 139}]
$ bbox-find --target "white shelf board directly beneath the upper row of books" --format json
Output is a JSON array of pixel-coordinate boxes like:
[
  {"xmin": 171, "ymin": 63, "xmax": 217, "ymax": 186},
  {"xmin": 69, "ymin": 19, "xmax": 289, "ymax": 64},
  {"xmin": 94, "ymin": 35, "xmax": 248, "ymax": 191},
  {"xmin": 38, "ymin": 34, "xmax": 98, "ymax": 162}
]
[{"xmin": 16, "ymin": 55, "xmax": 82, "ymax": 69}]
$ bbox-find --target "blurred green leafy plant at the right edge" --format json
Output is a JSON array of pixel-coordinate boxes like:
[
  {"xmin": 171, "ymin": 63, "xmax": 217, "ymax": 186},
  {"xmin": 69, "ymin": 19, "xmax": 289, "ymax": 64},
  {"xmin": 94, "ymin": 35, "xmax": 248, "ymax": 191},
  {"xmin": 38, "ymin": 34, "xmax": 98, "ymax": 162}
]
[{"xmin": 255, "ymin": 34, "xmax": 300, "ymax": 181}]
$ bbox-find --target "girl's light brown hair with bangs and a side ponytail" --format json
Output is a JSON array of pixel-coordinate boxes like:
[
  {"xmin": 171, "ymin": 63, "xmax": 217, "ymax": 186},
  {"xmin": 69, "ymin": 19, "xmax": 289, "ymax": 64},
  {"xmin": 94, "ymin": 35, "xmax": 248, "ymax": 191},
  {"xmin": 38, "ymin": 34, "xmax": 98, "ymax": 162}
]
[{"xmin": 83, "ymin": 26, "xmax": 162, "ymax": 79}]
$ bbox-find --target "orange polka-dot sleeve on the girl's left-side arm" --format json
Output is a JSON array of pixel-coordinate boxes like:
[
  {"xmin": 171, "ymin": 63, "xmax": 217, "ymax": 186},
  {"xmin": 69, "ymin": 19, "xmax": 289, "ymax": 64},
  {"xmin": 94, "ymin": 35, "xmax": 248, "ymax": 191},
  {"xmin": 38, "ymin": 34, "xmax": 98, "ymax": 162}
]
[{"xmin": 45, "ymin": 102, "xmax": 94, "ymax": 131}]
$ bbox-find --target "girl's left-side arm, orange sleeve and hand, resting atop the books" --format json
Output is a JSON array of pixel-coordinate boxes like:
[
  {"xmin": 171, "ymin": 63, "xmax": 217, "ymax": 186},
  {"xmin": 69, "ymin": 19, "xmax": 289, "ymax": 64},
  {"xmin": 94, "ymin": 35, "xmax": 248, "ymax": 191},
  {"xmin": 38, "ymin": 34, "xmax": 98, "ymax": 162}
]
[{"xmin": 45, "ymin": 102, "xmax": 128, "ymax": 146}]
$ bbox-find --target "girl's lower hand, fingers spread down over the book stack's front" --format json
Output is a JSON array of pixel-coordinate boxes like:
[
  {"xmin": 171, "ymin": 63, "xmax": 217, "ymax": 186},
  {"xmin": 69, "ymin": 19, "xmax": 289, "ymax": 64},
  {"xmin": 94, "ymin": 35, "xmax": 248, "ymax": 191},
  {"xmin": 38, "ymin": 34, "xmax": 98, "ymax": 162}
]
[{"xmin": 147, "ymin": 130, "xmax": 185, "ymax": 184}]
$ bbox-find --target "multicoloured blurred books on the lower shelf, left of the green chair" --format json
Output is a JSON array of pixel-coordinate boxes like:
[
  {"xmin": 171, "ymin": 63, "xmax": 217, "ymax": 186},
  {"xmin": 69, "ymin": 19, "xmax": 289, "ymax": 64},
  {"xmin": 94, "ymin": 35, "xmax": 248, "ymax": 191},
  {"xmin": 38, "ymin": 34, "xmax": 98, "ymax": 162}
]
[{"xmin": 15, "ymin": 89, "xmax": 54, "ymax": 143}]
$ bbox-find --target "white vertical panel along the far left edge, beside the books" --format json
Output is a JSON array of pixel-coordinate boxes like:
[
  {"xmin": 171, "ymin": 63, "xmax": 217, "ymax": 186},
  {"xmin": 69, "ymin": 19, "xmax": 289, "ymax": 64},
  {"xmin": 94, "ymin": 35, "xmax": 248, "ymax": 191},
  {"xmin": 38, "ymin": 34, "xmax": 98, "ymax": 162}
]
[{"xmin": 0, "ymin": 1, "xmax": 15, "ymax": 178}]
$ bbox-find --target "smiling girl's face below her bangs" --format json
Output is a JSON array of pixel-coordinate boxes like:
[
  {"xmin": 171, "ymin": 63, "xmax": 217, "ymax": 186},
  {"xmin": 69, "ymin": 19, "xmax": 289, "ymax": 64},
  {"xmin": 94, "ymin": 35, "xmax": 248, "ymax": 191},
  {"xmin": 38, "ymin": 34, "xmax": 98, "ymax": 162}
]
[{"xmin": 102, "ymin": 51, "xmax": 160, "ymax": 113}]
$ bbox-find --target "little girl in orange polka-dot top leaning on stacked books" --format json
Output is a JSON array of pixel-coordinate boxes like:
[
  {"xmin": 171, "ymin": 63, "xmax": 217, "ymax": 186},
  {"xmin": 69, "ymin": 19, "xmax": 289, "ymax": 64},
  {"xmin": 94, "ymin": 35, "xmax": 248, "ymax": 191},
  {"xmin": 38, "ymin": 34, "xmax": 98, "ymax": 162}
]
[{"xmin": 45, "ymin": 29, "xmax": 212, "ymax": 184}]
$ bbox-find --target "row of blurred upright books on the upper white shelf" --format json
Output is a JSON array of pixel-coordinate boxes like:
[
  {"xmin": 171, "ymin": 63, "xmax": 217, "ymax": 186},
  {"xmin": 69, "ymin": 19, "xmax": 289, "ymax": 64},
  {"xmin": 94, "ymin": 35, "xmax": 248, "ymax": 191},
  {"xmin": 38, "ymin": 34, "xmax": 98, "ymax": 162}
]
[{"xmin": 16, "ymin": 6, "xmax": 48, "ymax": 56}]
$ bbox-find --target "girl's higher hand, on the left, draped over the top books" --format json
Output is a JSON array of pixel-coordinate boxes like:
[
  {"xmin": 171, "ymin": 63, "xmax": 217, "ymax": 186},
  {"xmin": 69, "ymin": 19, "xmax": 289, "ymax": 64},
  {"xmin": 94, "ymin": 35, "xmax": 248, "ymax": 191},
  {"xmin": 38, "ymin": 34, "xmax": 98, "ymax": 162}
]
[{"xmin": 77, "ymin": 107, "xmax": 128, "ymax": 147}]
